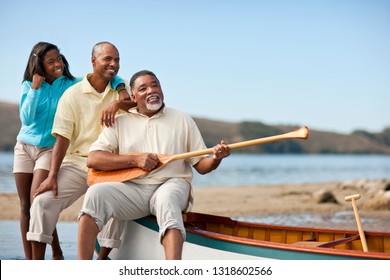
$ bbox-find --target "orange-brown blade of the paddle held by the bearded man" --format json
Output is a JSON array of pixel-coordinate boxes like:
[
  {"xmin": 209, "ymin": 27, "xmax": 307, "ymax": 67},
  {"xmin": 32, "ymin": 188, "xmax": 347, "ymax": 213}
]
[{"xmin": 87, "ymin": 154, "xmax": 175, "ymax": 186}]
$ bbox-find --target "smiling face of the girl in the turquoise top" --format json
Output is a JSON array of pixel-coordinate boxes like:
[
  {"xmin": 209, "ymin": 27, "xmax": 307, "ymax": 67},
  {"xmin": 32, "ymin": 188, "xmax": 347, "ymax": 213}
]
[{"xmin": 42, "ymin": 49, "xmax": 64, "ymax": 84}]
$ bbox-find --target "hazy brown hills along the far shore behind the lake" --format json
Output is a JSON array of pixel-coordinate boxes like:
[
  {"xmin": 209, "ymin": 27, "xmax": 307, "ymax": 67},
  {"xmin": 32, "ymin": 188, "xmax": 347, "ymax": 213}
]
[{"xmin": 0, "ymin": 102, "xmax": 390, "ymax": 154}]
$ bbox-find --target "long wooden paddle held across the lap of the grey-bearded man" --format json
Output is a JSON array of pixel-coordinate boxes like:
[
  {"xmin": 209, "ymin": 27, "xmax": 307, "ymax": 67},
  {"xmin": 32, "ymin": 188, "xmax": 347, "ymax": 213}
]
[{"xmin": 87, "ymin": 126, "xmax": 309, "ymax": 186}]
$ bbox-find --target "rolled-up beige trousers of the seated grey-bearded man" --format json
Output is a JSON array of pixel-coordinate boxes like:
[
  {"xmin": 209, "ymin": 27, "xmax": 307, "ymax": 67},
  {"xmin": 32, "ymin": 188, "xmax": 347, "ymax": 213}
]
[{"xmin": 79, "ymin": 178, "xmax": 191, "ymax": 248}]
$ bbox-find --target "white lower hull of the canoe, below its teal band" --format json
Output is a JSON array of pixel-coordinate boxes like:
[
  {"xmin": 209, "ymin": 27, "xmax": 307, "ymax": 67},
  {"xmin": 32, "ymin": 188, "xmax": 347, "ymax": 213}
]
[{"xmin": 109, "ymin": 221, "xmax": 267, "ymax": 260}]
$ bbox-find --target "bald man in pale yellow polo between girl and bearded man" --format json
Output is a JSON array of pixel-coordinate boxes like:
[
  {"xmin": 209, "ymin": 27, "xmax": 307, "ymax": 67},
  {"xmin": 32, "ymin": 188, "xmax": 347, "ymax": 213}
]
[{"xmin": 27, "ymin": 42, "xmax": 134, "ymax": 259}]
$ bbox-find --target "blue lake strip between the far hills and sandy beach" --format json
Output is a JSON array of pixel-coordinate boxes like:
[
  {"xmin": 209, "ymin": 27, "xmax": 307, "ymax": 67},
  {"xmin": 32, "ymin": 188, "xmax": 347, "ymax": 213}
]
[{"xmin": 0, "ymin": 153, "xmax": 390, "ymax": 193}]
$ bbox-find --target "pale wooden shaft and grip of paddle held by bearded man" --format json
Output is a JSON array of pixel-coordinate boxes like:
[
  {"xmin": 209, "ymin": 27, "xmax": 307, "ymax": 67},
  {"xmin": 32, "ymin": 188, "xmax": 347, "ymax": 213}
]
[{"xmin": 170, "ymin": 126, "xmax": 309, "ymax": 161}]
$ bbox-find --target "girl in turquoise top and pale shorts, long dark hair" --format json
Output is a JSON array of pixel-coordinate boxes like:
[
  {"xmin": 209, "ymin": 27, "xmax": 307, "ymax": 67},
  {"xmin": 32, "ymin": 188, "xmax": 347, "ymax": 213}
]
[{"xmin": 13, "ymin": 42, "xmax": 124, "ymax": 259}]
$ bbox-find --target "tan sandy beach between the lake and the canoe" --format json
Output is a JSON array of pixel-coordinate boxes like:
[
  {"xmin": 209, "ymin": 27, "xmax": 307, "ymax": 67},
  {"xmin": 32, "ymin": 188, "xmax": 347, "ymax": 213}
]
[{"xmin": 0, "ymin": 179, "xmax": 390, "ymax": 231}]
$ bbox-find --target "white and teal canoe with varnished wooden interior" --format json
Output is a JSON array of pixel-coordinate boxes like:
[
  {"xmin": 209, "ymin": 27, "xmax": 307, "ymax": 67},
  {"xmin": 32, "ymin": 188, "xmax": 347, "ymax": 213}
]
[{"xmin": 96, "ymin": 212, "xmax": 390, "ymax": 260}]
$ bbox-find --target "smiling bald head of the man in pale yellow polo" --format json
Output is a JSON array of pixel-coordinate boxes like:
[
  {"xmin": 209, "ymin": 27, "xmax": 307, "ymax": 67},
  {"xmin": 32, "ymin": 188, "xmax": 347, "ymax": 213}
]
[{"xmin": 92, "ymin": 43, "xmax": 119, "ymax": 81}]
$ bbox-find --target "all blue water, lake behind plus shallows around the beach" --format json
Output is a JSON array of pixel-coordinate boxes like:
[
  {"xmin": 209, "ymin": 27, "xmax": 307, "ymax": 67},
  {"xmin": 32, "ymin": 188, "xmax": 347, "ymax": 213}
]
[{"xmin": 0, "ymin": 153, "xmax": 390, "ymax": 259}]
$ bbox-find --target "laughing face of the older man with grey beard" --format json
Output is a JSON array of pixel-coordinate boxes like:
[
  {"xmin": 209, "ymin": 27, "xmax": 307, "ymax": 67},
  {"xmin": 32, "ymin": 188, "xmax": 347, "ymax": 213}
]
[{"xmin": 132, "ymin": 74, "xmax": 164, "ymax": 117}]
